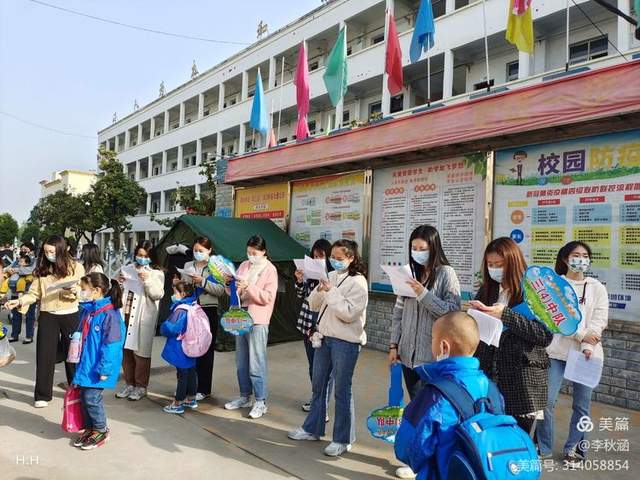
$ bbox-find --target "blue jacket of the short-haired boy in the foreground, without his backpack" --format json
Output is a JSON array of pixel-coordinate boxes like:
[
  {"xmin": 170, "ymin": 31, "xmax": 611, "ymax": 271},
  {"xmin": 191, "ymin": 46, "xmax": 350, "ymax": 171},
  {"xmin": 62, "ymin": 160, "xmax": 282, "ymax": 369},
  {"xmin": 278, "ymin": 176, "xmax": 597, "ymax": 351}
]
[{"xmin": 395, "ymin": 357, "xmax": 496, "ymax": 480}]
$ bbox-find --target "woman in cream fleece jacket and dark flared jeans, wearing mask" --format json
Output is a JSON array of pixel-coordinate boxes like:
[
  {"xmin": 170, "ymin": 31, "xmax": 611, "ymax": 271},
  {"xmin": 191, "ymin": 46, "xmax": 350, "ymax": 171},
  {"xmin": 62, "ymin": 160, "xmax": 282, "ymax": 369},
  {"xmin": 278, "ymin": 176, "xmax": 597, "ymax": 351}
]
[{"xmin": 289, "ymin": 240, "xmax": 369, "ymax": 457}]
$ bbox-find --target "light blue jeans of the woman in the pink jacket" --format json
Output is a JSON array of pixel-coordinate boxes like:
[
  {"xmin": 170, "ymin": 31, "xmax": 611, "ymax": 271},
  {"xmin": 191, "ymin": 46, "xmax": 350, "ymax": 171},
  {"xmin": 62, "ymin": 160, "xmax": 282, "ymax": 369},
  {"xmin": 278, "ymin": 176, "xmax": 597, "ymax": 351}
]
[{"xmin": 236, "ymin": 325, "xmax": 269, "ymax": 401}]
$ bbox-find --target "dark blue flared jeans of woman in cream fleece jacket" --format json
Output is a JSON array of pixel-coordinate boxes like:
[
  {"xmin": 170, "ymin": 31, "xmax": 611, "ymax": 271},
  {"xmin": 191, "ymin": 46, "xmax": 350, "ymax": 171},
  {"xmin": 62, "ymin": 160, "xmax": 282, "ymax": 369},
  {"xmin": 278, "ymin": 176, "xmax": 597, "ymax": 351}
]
[{"xmin": 302, "ymin": 337, "xmax": 360, "ymax": 444}]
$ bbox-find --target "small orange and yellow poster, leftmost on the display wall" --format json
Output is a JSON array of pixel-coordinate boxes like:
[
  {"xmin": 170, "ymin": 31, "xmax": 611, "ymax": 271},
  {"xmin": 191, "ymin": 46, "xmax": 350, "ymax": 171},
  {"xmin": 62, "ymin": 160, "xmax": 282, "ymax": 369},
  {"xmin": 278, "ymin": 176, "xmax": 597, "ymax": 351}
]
[{"xmin": 234, "ymin": 182, "xmax": 289, "ymax": 230}]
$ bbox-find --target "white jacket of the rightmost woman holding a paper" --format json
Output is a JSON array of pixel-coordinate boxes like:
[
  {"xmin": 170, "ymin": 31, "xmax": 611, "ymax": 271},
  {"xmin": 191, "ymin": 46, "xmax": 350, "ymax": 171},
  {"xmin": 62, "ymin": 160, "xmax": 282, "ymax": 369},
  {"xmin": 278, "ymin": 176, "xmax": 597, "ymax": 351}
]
[{"xmin": 547, "ymin": 277, "xmax": 609, "ymax": 361}]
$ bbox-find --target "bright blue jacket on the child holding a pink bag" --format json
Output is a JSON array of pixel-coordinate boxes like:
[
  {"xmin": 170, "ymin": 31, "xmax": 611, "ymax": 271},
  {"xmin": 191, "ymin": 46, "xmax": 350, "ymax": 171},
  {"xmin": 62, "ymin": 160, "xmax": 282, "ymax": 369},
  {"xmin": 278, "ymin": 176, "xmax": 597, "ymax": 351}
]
[{"xmin": 73, "ymin": 297, "xmax": 125, "ymax": 388}]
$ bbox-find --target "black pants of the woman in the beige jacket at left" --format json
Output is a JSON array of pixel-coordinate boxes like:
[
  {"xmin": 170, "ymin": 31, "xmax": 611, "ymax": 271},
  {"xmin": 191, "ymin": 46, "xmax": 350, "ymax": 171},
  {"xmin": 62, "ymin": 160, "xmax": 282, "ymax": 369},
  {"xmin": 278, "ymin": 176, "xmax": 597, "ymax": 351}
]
[{"xmin": 34, "ymin": 312, "xmax": 78, "ymax": 402}]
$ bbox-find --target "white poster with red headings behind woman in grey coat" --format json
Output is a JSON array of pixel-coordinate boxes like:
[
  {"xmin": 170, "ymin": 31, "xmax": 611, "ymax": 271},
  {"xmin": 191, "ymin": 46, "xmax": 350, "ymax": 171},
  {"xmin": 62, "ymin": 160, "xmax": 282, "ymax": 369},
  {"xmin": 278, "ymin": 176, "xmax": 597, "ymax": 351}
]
[{"xmin": 369, "ymin": 153, "xmax": 486, "ymax": 299}]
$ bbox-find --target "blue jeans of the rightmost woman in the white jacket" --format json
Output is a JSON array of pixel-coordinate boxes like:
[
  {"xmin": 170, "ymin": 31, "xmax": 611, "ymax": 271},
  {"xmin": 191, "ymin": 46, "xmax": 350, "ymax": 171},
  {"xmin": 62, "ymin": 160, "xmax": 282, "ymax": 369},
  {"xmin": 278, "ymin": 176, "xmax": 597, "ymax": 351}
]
[{"xmin": 537, "ymin": 358, "xmax": 592, "ymax": 455}]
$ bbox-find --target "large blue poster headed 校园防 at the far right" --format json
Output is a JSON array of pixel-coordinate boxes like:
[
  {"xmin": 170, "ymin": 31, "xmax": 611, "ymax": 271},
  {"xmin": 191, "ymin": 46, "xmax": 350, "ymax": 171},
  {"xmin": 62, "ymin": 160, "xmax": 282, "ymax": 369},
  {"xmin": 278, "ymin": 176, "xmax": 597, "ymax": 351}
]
[{"xmin": 493, "ymin": 130, "xmax": 640, "ymax": 321}]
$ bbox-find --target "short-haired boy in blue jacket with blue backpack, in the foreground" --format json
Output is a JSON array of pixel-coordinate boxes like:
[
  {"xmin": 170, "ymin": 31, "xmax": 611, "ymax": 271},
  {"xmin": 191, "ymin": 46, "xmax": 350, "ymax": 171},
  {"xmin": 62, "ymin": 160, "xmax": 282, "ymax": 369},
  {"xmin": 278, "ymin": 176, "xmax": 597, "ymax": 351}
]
[{"xmin": 395, "ymin": 312, "xmax": 540, "ymax": 480}]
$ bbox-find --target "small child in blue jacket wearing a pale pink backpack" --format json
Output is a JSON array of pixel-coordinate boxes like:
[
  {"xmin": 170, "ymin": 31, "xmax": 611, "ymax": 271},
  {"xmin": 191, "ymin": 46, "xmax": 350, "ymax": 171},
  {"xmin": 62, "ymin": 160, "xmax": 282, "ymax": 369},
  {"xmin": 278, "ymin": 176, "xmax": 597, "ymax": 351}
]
[{"xmin": 160, "ymin": 281, "xmax": 211, "ymax": 414}]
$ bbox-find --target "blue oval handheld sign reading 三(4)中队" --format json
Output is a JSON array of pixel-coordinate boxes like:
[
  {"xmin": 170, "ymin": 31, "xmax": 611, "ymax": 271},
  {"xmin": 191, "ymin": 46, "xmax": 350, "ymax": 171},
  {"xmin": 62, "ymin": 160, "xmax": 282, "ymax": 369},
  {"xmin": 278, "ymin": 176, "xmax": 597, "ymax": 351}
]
[{"xmin": 513, "ymin": 266, "xmax": 582, "ymax": 336}]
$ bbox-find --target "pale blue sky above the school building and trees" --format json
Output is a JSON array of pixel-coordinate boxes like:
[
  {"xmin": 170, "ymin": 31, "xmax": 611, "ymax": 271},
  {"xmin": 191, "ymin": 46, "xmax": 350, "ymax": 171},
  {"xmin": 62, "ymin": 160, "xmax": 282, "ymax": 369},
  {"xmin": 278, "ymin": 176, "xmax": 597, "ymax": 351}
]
[{"xmin": 0, "ymin": 0, "xmax": 321, "ymax": 222}]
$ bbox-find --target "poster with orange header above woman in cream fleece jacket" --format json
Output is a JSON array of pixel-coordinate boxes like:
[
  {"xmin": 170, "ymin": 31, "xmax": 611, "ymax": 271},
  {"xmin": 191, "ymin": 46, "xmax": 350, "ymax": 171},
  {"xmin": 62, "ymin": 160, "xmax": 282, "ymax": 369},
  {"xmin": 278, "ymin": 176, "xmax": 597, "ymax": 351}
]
[{"xmin": 289, "ymin": 172, "xmax": 365, "ymax": 248}]
